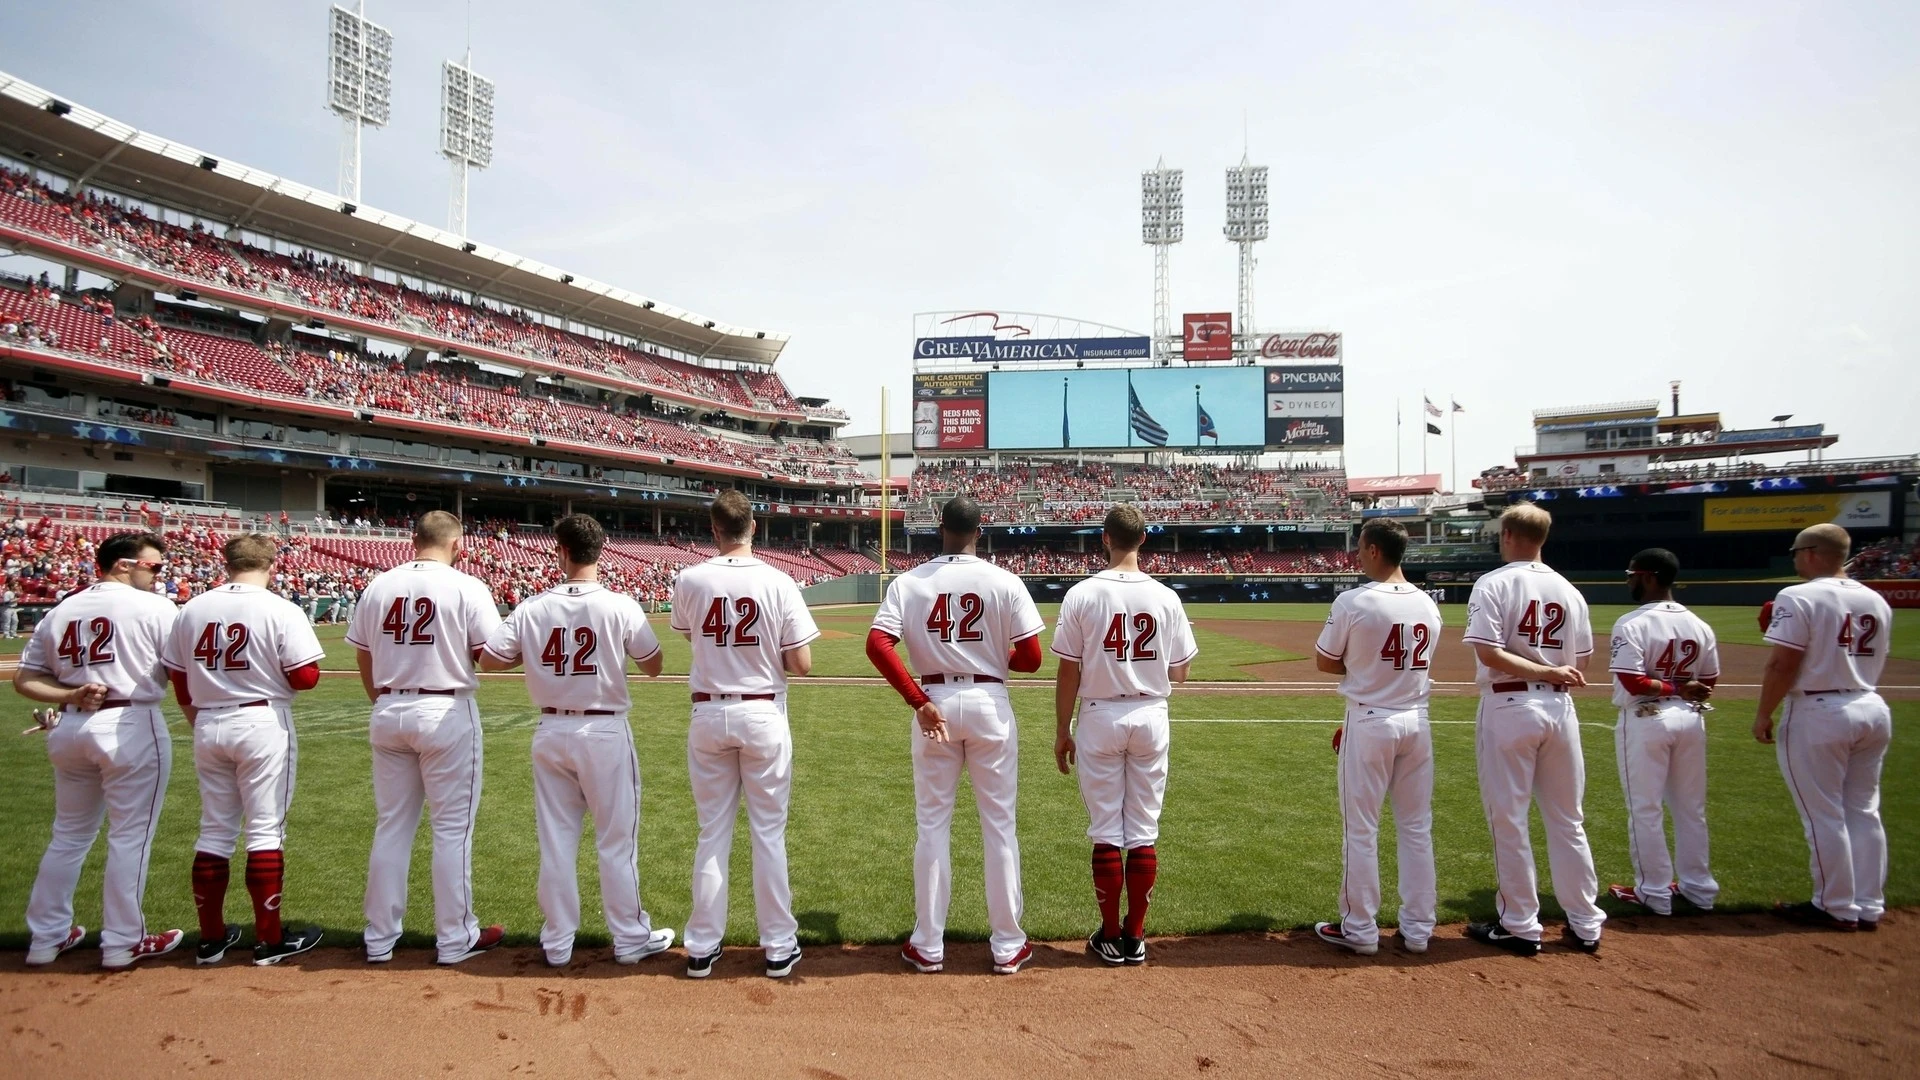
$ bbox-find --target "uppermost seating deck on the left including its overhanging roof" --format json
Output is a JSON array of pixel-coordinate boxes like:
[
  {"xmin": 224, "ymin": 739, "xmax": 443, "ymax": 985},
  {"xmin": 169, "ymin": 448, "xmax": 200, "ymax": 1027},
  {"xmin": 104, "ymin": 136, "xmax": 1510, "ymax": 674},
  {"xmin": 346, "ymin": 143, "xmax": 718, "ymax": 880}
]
[{"xmin": 0, "ymin": 73, "xmax": 845, "ymax": 427}]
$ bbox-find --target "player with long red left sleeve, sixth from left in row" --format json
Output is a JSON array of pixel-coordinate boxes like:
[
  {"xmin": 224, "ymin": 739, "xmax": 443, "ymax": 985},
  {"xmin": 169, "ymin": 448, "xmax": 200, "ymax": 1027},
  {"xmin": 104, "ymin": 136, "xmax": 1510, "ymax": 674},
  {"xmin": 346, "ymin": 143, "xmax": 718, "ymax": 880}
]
[{"xmin": 866, "ymin": 496, "xmax": 1044, "ymax": 974}]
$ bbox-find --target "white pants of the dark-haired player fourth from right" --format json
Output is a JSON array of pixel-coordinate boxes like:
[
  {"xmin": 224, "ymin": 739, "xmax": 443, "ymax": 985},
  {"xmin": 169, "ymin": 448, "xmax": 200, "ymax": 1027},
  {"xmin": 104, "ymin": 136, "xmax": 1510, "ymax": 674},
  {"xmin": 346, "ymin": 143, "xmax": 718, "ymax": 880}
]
[{"xmin": 1338, "ymin": 703, "xmax": 1438, "ymax": 945}]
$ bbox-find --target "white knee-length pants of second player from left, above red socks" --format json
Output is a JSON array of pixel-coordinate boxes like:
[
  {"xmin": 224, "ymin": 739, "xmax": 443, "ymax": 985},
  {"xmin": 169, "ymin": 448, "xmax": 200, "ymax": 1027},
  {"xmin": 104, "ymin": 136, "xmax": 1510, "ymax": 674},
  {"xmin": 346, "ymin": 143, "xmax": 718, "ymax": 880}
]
[{"xmin": 194, "ymin": 705, "xmax": 300, "ymax": 859}]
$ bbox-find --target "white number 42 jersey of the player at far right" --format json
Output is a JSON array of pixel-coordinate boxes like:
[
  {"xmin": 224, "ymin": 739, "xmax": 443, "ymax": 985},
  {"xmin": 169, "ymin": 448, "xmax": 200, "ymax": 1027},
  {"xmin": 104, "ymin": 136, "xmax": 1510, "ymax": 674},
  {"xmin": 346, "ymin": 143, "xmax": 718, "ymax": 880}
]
[{"xmin": 1766, "ymin": 578, "xmax": 1893, "ymax": 690}]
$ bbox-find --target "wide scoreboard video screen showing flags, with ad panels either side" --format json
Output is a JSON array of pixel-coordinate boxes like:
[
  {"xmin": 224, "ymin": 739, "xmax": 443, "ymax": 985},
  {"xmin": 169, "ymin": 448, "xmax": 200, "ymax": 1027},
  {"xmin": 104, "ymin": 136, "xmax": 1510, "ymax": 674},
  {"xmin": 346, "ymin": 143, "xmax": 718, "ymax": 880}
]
[{"xmin": 914, "ymin": 365, "xmax": 1344, "ymax": 452}]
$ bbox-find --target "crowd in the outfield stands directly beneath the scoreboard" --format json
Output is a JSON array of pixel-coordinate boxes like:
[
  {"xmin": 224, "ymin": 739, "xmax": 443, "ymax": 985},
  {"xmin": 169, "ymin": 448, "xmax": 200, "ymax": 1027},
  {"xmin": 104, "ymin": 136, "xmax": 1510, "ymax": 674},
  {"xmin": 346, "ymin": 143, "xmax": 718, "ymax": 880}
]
[{"xmin": 906, "ymin": 457, "xmax": 1350, "ymax": 525}]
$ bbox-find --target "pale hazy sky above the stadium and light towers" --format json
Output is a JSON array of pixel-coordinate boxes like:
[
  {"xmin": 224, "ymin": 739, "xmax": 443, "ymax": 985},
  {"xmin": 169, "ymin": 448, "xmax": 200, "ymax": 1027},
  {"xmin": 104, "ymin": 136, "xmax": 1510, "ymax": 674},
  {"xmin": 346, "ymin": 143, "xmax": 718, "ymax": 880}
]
[{"xmin": 0, "ymin": 0, "xmax": 1920, "ymax": 482}]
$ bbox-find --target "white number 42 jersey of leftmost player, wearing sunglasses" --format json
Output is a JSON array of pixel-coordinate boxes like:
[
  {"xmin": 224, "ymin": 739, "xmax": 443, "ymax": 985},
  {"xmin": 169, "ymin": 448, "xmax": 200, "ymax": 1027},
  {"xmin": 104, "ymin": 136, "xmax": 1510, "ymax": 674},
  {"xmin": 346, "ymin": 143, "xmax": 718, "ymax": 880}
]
[{"xmin": 19, "ymin": 580, "xmax": 180, "ymax": 705}]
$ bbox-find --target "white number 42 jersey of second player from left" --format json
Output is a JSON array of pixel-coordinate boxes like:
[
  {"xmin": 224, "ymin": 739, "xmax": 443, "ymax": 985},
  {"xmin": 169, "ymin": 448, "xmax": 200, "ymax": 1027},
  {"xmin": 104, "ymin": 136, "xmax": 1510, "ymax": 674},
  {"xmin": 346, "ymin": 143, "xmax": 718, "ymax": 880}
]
[{"xmin": 159, "ymin": 582, "xmax": 326, "ymax": 709}]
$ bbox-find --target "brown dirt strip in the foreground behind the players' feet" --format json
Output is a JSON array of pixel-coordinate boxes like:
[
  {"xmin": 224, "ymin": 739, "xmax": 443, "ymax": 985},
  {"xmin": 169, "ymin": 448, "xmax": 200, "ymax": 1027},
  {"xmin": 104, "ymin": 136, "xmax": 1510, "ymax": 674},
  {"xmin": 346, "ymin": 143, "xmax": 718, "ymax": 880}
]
[{"xmin": 0, "ymin": 911, "xmax": 1920, "ymax": 1080}]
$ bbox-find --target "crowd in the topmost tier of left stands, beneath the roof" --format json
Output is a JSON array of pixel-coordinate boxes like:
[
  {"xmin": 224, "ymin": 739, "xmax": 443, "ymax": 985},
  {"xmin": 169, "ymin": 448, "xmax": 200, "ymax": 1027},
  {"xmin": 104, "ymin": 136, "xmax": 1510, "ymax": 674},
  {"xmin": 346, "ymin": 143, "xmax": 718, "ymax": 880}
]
[{"xmin": 0, "ymin": 165, "xmax": 821, "ymax": 417}]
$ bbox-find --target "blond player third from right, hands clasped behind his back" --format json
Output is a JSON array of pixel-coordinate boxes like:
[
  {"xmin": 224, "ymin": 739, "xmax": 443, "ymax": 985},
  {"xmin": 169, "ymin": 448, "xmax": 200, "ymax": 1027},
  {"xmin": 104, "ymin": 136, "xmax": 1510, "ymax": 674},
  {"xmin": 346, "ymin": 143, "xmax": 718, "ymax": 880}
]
[{"xmin": 1467, "ymin": 503, "xmax": 1607, "ymax": 957}]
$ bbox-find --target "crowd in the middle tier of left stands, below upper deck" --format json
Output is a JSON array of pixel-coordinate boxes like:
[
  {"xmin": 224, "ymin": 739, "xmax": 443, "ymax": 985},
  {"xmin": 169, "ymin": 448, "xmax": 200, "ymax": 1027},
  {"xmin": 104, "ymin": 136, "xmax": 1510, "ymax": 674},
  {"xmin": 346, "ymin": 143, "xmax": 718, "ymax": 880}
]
[{"xmin": 0, "ymin": 284, "xmax": 862, "ymax": 484}]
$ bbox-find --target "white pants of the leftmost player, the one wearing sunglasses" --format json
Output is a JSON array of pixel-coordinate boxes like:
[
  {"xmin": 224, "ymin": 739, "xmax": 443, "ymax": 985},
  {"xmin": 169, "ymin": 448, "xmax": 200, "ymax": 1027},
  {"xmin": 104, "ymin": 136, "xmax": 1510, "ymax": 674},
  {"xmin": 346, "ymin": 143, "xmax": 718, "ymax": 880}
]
[{"xmin": 27, "ymin": 705, "xmax": 173, "ymax": 955}]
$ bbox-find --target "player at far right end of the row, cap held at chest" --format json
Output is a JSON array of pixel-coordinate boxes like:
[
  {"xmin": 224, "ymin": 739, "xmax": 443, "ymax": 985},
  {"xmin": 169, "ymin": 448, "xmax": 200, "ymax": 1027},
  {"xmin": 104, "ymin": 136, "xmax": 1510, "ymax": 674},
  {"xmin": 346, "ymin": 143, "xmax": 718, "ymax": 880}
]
[{"xmin": 1753, "ymin": 525, "xmax": 1893, "ymax": 930}]
